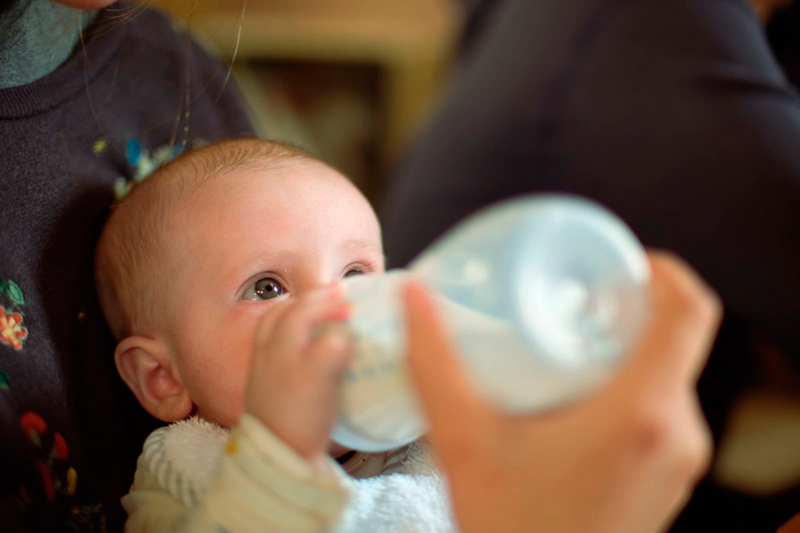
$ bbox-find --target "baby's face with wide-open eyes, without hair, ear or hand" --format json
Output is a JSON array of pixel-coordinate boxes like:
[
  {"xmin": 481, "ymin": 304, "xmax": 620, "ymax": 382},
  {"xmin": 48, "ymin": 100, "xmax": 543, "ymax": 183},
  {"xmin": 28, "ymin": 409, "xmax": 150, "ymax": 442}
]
[{"xmin": 164, "ymin": 161, "xmax": 384, "ymax": 427}]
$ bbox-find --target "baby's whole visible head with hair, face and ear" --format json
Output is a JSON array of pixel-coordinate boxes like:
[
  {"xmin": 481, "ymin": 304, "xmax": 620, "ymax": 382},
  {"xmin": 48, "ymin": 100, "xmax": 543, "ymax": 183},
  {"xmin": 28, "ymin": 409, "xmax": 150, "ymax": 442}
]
[{"xmin": 96, "ymin": 139, "xmax": 384, "ymax": 427}]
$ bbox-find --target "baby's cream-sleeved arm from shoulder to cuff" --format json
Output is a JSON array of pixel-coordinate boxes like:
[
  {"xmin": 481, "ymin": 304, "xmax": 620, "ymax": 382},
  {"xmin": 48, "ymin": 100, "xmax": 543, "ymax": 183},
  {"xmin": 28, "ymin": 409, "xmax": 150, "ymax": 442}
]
[{"xmin": 122, "ymin": 414, "xmax": 350, "ymax": 532}]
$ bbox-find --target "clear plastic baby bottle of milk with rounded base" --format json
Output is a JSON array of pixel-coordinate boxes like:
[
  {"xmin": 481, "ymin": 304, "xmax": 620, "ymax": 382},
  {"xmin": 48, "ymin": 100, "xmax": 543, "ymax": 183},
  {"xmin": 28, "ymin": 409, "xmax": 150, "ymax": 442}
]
[{"xmin": 333, "ymin": 195, "xmax": 650, "ymax": 451}]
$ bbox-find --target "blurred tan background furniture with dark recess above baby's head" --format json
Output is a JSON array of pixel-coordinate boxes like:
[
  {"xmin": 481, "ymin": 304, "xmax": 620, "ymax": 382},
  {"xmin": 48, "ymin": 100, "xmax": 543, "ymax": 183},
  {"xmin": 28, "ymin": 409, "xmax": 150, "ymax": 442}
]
[{"xmin": 154, "ymin": 0, "xmax": 462, "ymax": 201}]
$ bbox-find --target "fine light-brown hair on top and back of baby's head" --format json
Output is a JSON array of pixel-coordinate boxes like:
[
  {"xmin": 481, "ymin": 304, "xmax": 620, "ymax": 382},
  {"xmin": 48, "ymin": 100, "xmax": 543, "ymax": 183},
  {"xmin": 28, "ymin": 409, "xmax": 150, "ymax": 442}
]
[{"xmin": 95, "ymin": 138, "xmax": 315, "ymax": 341}]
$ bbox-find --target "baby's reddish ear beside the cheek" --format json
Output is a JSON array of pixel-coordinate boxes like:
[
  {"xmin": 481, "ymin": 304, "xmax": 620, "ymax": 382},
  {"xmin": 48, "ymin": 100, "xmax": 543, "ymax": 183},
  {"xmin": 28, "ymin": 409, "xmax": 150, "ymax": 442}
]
[{"xmin": 114, "ymin": 336, "xmax": 192, "ymax": 422}]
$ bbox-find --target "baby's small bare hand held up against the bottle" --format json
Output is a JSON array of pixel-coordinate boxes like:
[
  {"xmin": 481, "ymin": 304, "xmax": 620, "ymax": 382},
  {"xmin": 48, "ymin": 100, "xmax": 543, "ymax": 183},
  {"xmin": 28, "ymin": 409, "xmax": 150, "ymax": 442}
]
[{"xmin": 245, "ymin": 285, "xmax": 352, "ymax": 462}]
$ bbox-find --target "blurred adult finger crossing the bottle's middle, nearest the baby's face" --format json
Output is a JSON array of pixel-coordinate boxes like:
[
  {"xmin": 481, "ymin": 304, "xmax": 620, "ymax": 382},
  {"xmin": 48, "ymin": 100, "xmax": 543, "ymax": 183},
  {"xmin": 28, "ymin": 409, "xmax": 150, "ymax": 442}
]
[{"xmin": 403, "ymin": 282, "xmax": 488, "ymax": 448}]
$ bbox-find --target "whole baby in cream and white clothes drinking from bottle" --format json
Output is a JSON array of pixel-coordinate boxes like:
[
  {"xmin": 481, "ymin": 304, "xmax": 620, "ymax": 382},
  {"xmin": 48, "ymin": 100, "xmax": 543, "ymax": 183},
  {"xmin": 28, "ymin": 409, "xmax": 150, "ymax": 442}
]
[{"xmin": 96, "ymin": 139, "xmax": 452, "ymax": 531}]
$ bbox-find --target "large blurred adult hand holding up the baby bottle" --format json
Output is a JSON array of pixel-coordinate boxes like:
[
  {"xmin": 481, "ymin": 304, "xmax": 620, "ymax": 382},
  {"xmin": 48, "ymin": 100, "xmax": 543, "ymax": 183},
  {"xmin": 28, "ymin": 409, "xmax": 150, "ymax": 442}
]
[{"xmin": 405, "ymin": 250, "xmax": 721, "ymax": 533}]
